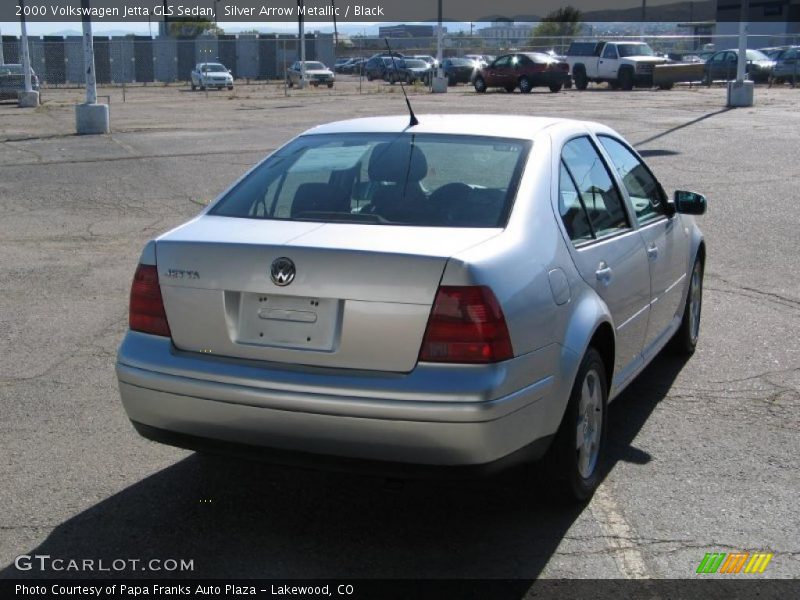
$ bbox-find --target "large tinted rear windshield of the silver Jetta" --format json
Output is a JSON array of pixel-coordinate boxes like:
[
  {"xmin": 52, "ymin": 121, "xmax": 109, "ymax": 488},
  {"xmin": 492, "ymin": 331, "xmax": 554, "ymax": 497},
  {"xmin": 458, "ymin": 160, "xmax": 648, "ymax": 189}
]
[{"xmin": 210, "ymin": 133, "xmax": 530, "ymax": 227}]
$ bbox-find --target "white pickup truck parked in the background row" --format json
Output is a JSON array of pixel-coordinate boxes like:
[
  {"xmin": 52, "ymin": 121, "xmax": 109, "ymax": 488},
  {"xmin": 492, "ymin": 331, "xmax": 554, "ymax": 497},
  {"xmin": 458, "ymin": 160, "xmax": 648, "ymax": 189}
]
[{"xmin": 566, "ymin": 42, "xmax": 673, "ymax": 90}]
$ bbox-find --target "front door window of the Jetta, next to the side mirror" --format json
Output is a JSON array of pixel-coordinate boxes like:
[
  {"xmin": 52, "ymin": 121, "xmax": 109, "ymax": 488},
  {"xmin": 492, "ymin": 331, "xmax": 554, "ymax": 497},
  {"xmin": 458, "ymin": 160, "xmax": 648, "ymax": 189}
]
[{"xmin": 598, "ymin": 135, "xmax": 666, "ymax": 224}]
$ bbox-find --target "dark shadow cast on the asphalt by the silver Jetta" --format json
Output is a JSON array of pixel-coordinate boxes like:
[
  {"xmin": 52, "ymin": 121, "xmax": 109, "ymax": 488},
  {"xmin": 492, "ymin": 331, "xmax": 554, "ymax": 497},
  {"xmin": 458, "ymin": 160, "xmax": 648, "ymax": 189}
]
[{"xmin": 0, "ymin": 357, "xmax": 684, "ymax": 579}]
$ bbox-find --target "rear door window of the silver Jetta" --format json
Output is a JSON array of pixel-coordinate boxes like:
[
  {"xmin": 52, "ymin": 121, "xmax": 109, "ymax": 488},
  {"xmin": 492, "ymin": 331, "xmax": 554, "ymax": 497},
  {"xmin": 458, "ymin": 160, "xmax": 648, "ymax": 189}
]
[{"xmin": 561, "ymin": 137, "xmax": 630, "ymax": 238}]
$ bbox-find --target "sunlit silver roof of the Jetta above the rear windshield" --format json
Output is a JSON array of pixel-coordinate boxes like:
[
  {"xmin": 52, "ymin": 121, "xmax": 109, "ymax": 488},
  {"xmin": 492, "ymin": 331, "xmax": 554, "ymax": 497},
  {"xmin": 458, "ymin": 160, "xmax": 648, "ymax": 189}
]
[{"xmin": 303, "ymin": 114, "xmax": 607, "ymax": 140}]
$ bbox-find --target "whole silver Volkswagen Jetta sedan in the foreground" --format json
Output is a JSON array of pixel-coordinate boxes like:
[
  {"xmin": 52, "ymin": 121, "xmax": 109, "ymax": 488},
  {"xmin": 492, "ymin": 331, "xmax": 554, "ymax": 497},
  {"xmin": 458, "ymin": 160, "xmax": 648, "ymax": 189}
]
[{"xmin": 117, "ymin": 115, "xmax": 706, "ymax": 499}]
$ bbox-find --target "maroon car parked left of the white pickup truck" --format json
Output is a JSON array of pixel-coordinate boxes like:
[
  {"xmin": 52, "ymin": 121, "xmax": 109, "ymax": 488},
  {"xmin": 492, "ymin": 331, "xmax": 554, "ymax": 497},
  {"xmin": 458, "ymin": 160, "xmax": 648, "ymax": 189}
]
[{"xmin": 473, "ymin": 52, "xmax": 569, "ymax": 94}]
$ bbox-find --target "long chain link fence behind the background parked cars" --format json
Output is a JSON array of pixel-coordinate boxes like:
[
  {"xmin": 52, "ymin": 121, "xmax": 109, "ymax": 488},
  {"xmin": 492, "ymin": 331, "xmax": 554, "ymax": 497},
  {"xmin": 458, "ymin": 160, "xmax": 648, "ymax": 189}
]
[{"xmin": 2, "ymin": 33, "xmax": 800, "ymax": 88}]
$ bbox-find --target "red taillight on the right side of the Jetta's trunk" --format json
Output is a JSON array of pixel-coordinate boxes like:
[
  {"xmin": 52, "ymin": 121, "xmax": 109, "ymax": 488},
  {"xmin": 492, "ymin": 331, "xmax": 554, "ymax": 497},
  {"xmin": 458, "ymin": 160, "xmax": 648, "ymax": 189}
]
[{"xmin": 419, "ymin": 285, "xmax": 514, "ymax": 363}]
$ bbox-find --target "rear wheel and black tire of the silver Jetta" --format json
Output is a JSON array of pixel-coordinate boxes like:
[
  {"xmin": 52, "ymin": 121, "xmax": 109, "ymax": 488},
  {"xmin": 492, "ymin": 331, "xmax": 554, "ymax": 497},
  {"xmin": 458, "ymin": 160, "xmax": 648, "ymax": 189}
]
[{"xmin": 544, "ymin": 347, "xmax": 608, "ymax": 502}]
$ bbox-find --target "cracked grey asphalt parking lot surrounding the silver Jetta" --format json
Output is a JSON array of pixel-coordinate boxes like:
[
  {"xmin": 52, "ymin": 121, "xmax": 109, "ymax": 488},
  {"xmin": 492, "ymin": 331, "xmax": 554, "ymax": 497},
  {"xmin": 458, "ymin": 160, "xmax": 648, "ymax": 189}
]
[{"xmin": 0, "ymin": 80, "xmax": 800, "ymax": 578}]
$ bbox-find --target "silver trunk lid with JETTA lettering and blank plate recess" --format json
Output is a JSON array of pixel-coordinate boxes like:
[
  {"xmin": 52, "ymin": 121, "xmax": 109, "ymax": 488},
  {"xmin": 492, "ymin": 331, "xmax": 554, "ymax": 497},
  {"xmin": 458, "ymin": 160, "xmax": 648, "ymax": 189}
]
[{"xmin": 156, "ymin": 216, "xmax": 500, "ymax": 372}]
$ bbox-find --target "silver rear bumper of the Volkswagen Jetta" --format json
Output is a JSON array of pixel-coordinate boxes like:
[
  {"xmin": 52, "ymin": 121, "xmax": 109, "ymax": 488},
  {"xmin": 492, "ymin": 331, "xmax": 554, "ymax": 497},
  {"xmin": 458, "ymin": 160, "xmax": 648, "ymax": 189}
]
[{"xmin": 117, "ymin": 332, "xmax": 563, "ymax": 466}]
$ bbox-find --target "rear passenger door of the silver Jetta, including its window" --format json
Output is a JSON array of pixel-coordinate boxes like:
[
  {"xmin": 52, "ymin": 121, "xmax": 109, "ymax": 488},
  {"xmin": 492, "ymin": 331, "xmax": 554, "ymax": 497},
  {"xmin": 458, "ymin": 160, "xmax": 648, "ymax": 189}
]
[{"xmin": 559, "ymin": 135, "xmax": 650, "ymax": 385}]
